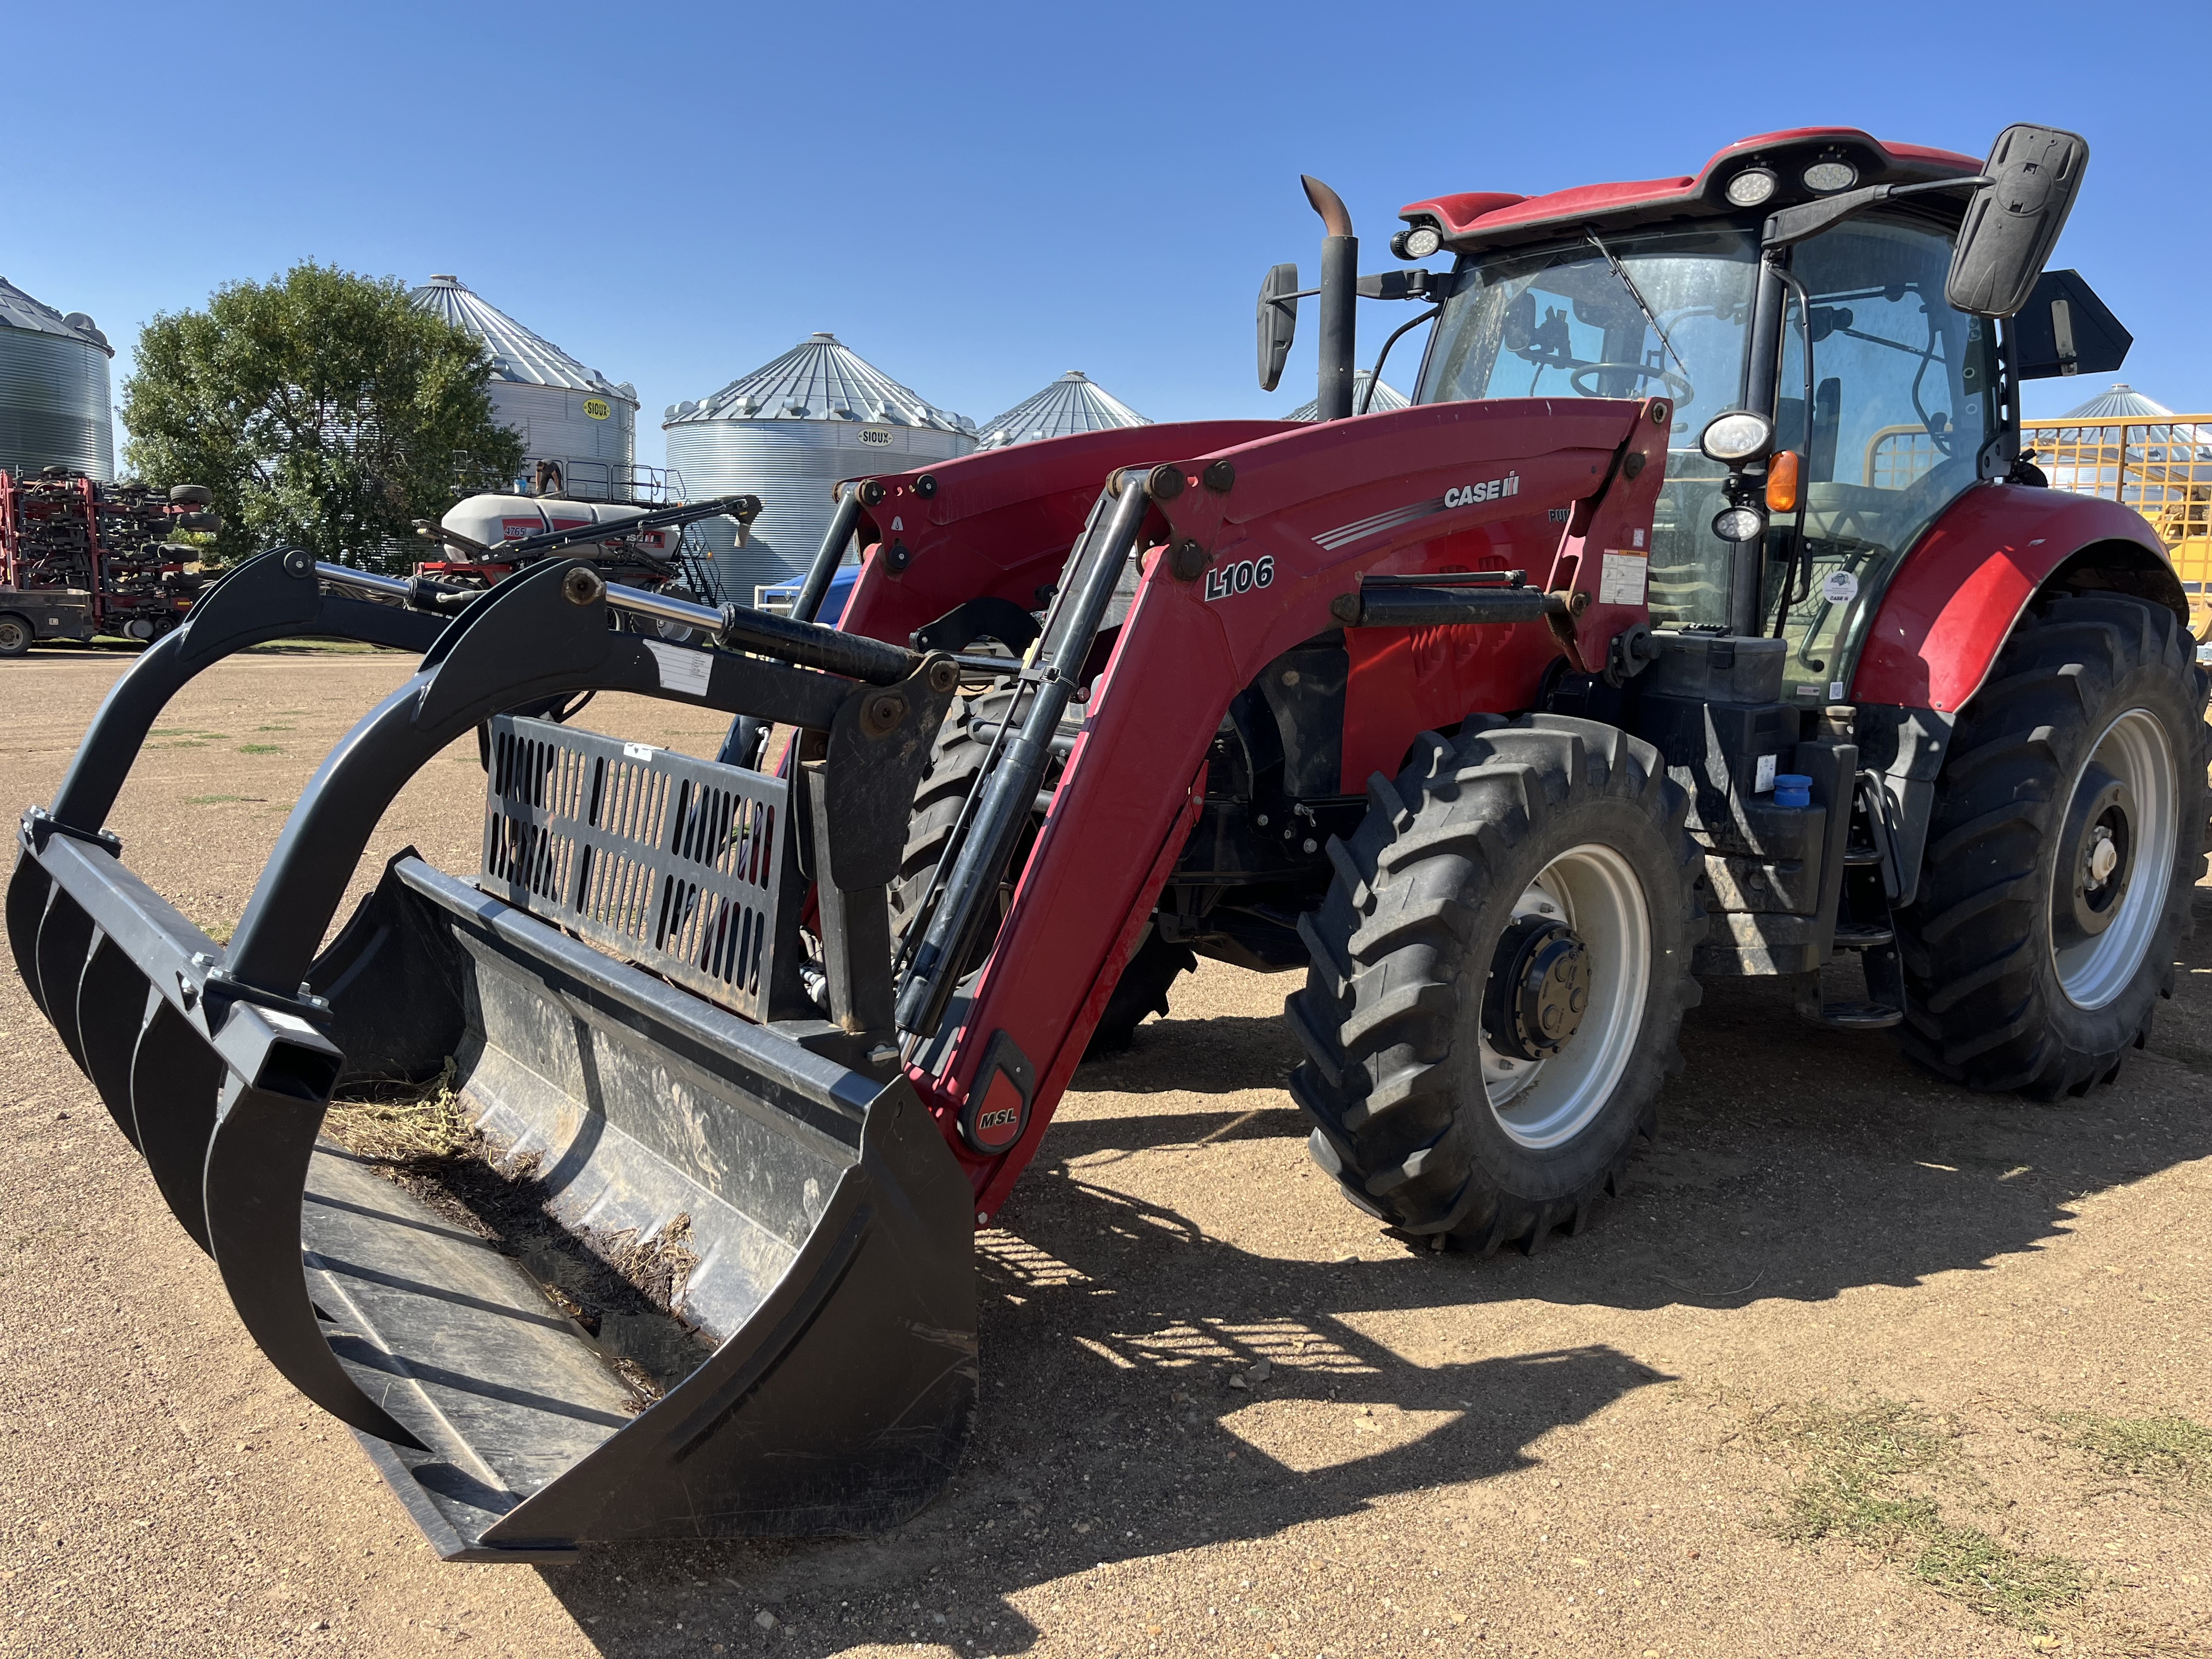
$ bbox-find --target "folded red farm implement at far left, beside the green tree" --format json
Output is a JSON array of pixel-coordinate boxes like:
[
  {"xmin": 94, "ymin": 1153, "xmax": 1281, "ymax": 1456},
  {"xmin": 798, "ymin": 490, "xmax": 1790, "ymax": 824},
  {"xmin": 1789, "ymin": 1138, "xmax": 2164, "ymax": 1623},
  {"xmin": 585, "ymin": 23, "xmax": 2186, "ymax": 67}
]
[{"xmin": 0, "ymin": 467, "xmax": 221, "ymax": 657}]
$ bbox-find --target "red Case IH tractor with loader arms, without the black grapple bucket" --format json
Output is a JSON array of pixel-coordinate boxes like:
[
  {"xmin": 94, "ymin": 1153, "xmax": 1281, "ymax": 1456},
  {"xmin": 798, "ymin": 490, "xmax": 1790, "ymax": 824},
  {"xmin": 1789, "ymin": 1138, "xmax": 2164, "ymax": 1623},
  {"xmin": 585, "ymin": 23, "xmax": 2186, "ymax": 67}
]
[{"xmin": 843, "ymin": 128, "xmax": 2205, "ymax": 1250}]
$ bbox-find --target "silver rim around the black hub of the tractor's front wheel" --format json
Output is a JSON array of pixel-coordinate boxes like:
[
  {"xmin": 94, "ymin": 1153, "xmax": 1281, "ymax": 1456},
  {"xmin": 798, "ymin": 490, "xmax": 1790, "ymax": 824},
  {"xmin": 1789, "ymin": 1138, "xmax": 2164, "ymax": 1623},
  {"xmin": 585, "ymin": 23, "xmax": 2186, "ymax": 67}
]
[{"xmin": 1482, "ymin": 843, "xmax": 1652, "ymax": 1150}]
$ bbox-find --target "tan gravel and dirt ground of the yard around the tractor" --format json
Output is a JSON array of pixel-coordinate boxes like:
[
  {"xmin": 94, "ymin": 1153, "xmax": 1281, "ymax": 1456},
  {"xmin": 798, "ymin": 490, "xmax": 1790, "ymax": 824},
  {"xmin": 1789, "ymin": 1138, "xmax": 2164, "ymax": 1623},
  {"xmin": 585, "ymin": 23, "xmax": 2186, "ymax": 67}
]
[{"xmin": 0, "ymin": 650, "xmax": 2212, "ymax": 1659}]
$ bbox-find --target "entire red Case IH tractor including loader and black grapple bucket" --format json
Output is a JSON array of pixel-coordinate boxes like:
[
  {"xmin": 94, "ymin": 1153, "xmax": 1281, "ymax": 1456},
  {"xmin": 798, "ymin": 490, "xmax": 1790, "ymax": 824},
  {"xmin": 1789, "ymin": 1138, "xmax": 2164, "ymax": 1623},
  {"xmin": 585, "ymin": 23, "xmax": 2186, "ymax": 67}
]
[{"xmin": 7, "ymin": 126, "xmax": 2208, "ymax": 1560}]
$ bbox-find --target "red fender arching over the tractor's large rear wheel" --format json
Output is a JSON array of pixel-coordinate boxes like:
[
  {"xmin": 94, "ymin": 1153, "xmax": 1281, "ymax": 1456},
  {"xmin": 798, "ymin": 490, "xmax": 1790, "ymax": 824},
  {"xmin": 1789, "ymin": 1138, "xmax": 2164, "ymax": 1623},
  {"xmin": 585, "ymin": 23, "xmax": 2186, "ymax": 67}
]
[{"xmin": 1852, "ymin": 484, "xmax": 2181, "ymax": 712}]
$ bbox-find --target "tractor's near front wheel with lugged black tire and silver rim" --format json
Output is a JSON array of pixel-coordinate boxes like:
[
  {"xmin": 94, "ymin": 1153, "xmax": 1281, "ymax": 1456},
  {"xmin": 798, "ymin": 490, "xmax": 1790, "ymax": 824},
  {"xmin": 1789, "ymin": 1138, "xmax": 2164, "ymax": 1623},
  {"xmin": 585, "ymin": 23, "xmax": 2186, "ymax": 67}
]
[{"xmin": 1285, "ymin": 714, "xmax": 1706, "ymax": 1254}]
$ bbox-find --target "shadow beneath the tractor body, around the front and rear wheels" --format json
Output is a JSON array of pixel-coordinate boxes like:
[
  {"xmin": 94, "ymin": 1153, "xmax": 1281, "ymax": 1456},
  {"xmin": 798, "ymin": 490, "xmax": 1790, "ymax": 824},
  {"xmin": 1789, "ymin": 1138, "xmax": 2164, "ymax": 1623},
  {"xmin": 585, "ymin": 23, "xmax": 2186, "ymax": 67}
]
[{"xmin": 1048, "ymin": 889, "xmax": 2212, "ymax": 1312}]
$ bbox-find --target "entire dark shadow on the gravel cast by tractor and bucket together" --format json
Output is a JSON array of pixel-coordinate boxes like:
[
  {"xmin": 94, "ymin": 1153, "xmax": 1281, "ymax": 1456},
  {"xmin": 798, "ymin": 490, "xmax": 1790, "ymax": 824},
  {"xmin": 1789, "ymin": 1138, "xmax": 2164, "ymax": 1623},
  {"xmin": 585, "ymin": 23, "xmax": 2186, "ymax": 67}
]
[{"xmin": 544, "ymin": 894, "xmax": 2212, "ymax": 1659}]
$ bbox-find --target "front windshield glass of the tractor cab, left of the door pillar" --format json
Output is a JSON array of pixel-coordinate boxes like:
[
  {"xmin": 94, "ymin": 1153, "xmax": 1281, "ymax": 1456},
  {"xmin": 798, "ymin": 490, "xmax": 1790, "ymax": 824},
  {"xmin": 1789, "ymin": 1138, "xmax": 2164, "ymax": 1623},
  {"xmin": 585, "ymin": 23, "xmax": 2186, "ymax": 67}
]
[{"xmin": 1415, "ymin": 225, "xmax": 1758, "ymax": 628}]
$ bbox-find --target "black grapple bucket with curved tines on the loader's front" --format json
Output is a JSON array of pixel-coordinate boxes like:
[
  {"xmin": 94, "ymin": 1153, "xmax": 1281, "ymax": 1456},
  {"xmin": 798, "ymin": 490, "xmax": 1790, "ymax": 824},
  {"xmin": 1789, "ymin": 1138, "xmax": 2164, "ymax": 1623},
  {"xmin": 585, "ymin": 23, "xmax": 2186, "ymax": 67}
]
[{"xmin": 9, "ymin": 555, "xmax": 975, "ymax": 1560}]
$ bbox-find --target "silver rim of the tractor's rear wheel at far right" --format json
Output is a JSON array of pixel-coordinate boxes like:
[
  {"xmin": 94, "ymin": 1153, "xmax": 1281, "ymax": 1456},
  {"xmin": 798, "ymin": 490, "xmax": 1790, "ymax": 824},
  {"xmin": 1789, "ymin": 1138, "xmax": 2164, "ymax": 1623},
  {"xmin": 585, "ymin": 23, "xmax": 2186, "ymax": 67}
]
[{"xmin": 2051, "ymin": 708, "xmax": 2181, "ymax": 1009}]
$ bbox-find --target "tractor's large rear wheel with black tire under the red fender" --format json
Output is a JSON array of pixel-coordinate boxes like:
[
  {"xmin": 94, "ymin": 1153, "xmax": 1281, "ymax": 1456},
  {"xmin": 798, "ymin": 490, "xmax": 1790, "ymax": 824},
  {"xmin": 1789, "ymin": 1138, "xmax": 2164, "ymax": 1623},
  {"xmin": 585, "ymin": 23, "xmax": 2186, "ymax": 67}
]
[{"xmin": 1898, "ymin": 593, "xmax": 2212, "ymax": 1099}]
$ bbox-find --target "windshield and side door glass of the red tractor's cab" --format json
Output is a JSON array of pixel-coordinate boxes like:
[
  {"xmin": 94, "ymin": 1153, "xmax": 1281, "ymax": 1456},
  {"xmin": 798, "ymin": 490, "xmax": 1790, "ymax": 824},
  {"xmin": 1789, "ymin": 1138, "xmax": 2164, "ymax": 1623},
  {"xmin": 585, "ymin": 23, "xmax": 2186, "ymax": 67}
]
[{"xmin": 1415, "ymin": 210, "xmax": 2000, "ymax": 701}]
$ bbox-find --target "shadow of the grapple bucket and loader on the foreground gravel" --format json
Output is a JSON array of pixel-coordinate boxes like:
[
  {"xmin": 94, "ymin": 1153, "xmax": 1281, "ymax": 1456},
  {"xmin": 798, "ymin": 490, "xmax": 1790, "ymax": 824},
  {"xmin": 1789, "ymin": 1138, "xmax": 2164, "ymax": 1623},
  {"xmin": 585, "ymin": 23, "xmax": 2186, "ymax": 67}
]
[{"xmin": 526, "ymin": 1172, "xmax": 1670, "ymax": 1659}]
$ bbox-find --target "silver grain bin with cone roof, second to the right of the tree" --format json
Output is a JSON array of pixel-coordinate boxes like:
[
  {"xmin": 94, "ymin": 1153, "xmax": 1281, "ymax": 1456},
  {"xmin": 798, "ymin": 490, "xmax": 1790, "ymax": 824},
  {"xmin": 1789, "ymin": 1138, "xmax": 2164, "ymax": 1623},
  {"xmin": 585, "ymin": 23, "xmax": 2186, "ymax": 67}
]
[{"xmin": 662, "ymin": 334, "xmax": 975, "ymax": 600}]
